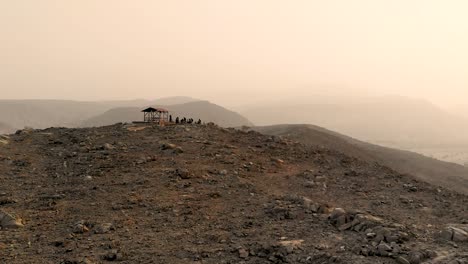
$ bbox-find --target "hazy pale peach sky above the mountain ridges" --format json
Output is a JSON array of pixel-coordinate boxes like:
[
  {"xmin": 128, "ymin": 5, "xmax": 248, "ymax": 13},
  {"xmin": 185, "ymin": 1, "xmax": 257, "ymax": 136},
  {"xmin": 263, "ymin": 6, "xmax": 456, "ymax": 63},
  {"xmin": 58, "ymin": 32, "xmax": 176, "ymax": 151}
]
[{"xmin": 0, "ymin": 0, "xmax": 468, "ymax": 105}]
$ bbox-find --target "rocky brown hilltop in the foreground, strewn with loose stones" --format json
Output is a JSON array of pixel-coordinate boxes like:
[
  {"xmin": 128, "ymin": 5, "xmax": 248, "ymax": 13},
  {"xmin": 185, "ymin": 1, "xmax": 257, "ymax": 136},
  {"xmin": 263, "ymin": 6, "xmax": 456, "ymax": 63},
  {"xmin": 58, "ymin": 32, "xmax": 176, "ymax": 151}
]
[{"xmin": 0, "ymin": 124, "xmax": 468, "ymax": 264}]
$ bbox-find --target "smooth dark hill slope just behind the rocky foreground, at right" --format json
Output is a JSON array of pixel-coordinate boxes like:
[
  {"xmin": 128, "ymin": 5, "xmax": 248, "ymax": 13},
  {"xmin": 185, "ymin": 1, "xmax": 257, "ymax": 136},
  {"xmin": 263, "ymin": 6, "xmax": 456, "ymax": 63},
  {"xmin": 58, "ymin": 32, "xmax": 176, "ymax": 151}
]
[{"xmin": 253, "ymin": 125, "xmax": 468, "ymax": 194}]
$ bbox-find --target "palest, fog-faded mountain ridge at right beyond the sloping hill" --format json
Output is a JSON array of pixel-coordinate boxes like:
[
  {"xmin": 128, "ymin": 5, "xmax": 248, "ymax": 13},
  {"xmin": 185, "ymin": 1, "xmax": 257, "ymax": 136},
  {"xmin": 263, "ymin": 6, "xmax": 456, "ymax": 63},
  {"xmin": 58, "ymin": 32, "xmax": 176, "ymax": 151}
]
[{"xmin": 240, "ymin": 96, "xmax": 468, "ymax": 147}]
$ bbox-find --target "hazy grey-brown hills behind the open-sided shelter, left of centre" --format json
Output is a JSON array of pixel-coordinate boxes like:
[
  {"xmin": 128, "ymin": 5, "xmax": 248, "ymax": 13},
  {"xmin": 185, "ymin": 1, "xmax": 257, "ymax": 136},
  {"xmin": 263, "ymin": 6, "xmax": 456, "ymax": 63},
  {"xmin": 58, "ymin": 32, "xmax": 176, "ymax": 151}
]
[{"xmin": 0, "ymin": 96, "xmax": 251, "ymax": 133}]
